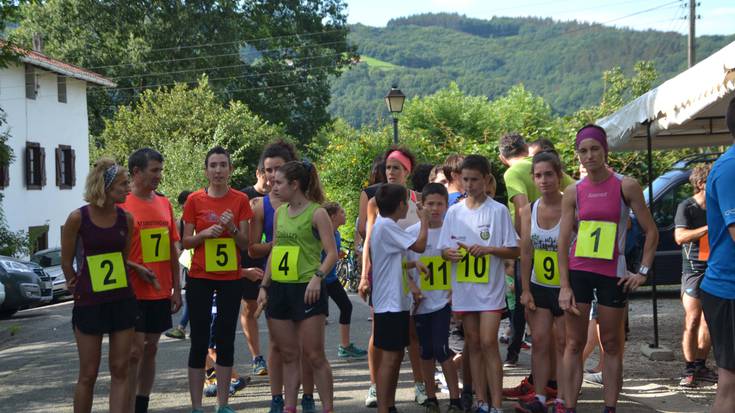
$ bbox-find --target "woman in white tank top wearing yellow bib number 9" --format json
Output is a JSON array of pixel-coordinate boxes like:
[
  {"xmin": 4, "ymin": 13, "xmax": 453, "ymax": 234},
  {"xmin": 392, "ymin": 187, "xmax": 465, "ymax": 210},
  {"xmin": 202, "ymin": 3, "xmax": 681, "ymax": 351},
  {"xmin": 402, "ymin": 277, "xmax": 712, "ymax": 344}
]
[{"xmin": 515, "ymin": 151, "xmax": 565, "ymax": 413}]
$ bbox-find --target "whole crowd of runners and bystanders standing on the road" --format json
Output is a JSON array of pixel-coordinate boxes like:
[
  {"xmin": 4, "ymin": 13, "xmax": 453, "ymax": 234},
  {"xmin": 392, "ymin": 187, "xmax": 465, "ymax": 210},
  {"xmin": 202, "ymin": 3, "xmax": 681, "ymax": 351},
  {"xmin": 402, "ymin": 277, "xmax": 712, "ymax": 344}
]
[{"xmin": 62, "ymin": 100, "xmax": 735, "ymax": 413}]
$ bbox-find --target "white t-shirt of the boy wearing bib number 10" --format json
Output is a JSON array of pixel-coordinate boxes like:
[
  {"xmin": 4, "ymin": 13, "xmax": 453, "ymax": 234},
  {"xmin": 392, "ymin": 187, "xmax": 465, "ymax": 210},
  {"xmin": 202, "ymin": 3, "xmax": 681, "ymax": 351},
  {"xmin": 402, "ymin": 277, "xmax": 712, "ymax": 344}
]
[{"xmin": 439, "ymin": 198, "xmax": 518, "ymax": 311}]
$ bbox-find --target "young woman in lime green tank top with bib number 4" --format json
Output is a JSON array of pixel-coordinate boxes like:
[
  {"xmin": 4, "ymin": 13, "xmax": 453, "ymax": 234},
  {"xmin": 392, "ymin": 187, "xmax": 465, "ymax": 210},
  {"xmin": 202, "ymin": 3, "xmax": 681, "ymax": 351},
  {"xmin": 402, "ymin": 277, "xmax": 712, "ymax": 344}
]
[{"xmin": 258, "ymin": 161, "xmax": 337, "ymax": 413}]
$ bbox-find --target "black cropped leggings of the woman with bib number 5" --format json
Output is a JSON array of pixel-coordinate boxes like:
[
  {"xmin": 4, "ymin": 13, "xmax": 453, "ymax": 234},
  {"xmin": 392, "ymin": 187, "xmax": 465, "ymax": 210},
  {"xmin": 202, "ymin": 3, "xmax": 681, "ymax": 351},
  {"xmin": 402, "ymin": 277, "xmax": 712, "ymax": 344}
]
[{"xmin": 186, "ymin": 278, "xmax": 242, "ymax": 369}]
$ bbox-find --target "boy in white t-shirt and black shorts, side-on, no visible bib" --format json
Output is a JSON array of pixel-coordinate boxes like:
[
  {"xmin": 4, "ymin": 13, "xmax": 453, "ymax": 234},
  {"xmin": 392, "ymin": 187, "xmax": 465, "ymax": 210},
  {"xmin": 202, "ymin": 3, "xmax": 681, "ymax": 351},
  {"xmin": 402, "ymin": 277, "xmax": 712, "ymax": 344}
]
[{"xmin": 370, "ymin": 184, "xmax": 429, "ymax": 413}]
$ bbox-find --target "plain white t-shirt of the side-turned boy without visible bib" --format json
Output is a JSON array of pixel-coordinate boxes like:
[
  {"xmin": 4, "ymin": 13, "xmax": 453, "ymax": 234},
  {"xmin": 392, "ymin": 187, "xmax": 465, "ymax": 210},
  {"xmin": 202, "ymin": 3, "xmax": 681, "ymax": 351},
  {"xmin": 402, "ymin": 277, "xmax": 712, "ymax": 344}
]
[{"xmin": 370, "ymin": 215, "xmax": 416, "ymax": 313}]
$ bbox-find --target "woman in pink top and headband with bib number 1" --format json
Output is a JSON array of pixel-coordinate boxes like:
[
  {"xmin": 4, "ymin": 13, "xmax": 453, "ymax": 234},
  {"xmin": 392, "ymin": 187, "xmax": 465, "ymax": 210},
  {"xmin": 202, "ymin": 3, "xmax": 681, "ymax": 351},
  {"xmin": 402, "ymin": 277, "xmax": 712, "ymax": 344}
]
[{"xmin": 558, "ymin": 125, "xmax": 658, "ymax": 413}]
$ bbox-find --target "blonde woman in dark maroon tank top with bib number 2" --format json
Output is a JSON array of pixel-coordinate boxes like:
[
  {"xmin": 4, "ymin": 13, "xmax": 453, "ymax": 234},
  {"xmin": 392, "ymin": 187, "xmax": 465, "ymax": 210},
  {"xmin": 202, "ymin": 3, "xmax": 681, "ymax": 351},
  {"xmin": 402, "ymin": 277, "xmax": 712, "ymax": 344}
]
[{"xmin": 61, "ymin": 158, "xmax": 137, "ymax": 413}]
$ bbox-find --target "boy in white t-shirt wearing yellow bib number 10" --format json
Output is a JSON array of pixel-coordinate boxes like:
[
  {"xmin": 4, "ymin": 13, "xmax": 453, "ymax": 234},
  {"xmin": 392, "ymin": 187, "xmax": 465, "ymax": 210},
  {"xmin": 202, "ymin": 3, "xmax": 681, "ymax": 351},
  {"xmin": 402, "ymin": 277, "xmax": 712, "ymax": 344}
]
[{"xmin": 439, "ymin": 155, "xmax": 520, "ymax": 413}]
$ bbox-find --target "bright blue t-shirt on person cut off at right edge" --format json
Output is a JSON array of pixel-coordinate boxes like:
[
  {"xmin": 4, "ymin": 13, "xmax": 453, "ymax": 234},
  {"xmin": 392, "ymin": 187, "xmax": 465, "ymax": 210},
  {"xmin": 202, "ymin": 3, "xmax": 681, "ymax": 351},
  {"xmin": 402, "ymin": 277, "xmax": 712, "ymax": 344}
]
[{"xmin": 700, "ymin": 145, "xmax": 735, "ymax": 300}]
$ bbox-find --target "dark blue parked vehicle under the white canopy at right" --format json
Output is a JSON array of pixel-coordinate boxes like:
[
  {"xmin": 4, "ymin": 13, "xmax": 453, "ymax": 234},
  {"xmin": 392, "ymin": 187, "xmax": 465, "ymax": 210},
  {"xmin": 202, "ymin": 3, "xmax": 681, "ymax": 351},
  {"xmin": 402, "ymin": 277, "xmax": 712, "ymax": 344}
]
[{"xmin": 626, "ymin": 153, "xmax": 721, "ymax": 285}]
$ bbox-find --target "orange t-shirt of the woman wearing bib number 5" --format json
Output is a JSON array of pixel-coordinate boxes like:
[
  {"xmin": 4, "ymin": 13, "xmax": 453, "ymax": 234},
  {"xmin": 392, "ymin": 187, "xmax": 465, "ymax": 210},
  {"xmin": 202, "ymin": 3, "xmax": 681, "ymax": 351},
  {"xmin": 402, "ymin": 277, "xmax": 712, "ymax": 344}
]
[{"xmin": 183, "ymin": 188, "xmax": 253, "ymax": 280}]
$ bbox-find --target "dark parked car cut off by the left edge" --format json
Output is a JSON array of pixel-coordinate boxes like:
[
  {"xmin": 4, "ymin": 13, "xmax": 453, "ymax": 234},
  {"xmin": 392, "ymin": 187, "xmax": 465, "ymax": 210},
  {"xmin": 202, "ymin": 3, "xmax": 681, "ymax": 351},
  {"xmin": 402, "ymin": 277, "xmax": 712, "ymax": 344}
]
[{"xmin": 0, "ymin": 255, "xmax": 53, "ymax": 317}]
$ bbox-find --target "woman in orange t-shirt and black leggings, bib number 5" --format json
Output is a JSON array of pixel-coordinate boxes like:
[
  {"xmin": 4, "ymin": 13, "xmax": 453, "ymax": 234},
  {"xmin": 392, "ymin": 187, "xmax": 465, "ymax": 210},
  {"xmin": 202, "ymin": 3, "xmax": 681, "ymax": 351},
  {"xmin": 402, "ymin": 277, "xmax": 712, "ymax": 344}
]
[{"xmin": 182, "ymin": 146, "xmax": 253, "ymax": 413}]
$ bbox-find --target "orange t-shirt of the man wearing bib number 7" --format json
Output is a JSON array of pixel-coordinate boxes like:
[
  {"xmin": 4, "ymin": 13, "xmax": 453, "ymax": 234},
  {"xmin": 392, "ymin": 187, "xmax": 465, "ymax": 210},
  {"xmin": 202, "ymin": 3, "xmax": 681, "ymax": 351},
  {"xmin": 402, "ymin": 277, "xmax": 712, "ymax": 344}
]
[{"xmin": 120, "ymin": 194, "xmax": 179, "ymax": 300}]
